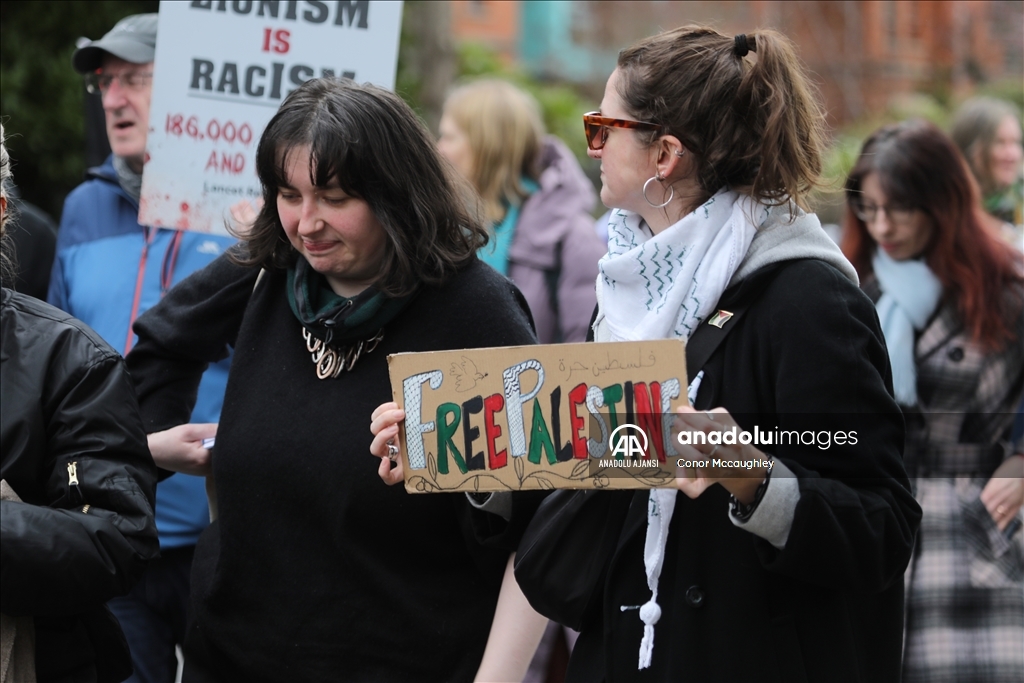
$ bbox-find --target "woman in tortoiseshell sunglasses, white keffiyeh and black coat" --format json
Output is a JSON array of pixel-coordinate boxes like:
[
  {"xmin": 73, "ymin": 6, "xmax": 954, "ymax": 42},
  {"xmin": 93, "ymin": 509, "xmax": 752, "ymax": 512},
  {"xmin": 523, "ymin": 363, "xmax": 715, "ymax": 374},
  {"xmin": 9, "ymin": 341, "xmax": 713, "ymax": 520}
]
[{"xmin": 503, "ymin": 27, "xmax": 920, "ymax": 681}]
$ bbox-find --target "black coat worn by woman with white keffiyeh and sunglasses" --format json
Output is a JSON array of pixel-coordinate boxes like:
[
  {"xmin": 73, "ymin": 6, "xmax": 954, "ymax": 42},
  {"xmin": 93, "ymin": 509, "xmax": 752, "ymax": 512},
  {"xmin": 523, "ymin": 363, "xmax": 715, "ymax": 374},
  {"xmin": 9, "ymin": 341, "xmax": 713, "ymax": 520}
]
[{"xmin": 568, "ymin": 260, "xmax": 921, "ymax": 683}]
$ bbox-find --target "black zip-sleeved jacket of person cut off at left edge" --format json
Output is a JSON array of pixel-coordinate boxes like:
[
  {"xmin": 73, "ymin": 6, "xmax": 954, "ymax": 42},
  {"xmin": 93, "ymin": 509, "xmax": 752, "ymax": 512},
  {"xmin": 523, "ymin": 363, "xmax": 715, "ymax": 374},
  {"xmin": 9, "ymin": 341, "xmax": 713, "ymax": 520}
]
[{"xmin": 0, "ymin": 289, "xmax": 159, "ymax": 683}]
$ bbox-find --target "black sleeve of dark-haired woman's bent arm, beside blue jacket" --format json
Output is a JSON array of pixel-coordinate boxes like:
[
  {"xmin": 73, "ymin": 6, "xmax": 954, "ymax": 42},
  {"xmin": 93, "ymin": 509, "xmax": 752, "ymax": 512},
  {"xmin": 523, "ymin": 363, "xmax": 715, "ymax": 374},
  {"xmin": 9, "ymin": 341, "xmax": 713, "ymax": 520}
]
[{"xmin": 128, "ymin": 254, "xmax": 259, "ymax": 433}]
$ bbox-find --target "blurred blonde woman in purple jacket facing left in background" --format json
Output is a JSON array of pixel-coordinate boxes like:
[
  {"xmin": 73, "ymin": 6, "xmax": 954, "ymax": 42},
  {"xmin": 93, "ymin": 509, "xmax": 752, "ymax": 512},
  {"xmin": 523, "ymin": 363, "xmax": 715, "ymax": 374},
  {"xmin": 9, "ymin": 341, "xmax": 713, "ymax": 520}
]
[{"xmin": 437, "ymin": 79, "xmax": 605, "ymax": 343}]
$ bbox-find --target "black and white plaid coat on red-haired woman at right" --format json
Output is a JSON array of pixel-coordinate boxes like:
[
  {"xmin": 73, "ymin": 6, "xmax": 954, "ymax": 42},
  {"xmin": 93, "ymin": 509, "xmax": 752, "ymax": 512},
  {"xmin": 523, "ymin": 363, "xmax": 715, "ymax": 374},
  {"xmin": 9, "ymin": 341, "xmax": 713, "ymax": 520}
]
[{"xmin": 880, "ymin": 287, "xmax": 1024, "ymax": 683}]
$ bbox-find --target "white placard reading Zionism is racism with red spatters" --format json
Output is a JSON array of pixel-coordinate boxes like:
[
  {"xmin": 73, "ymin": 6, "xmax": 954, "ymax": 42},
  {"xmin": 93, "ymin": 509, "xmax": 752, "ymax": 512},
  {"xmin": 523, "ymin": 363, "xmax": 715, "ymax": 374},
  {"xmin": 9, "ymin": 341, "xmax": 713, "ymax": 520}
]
[{"xmin": 138, "ymin": 0, "xmax": 402, "ymax": 234}]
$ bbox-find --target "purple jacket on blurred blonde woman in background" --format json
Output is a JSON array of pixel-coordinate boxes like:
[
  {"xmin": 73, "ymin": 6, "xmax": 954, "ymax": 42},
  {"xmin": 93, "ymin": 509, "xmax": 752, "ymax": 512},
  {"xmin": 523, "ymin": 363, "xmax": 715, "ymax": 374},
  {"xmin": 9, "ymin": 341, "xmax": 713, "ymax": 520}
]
[{"xmin": 509, "ymin": 136, "xmax": 607, "ymax": 344}]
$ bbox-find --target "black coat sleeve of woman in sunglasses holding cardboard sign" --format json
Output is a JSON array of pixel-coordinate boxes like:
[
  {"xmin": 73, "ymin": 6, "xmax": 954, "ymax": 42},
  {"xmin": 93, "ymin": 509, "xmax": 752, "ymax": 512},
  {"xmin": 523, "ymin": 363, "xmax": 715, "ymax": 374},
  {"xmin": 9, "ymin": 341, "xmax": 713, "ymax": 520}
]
[{"xmin": 733, "ymin": 261, "xmax": 921, "ymax": 593}]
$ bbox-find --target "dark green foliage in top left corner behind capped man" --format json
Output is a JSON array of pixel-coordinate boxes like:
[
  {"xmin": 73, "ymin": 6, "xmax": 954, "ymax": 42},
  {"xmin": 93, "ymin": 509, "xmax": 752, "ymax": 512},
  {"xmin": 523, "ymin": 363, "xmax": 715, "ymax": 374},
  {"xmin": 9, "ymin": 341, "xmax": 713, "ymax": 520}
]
[{"xmin": 0, "ymin": 0, "xmax": 159, "ymax": 218}]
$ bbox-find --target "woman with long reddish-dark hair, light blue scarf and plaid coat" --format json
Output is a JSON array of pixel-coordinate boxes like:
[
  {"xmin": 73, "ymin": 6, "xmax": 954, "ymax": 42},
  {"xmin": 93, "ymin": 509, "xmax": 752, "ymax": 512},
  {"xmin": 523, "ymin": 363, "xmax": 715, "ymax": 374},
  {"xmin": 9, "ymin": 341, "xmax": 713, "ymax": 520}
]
[{"xmin": 843, "ymin": 121, "xmax": 1024, "ymax": 682}]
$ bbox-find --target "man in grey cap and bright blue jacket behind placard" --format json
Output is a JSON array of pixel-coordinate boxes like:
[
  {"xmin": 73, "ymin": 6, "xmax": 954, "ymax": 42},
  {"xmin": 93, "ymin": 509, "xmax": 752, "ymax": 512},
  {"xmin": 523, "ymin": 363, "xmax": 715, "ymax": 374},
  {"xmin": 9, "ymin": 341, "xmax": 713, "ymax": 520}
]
[{"xmin": 47, "ymin": 14, "xmax": 233, "ymax": 682}]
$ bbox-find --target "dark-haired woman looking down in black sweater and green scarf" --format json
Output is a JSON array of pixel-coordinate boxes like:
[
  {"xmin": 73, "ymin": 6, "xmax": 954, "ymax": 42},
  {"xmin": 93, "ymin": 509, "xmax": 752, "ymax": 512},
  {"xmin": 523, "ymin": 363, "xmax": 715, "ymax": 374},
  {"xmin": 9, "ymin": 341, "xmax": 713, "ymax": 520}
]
[{"xmin": 128, "ymin": 79, "xmax": 536, "ymax": 681}]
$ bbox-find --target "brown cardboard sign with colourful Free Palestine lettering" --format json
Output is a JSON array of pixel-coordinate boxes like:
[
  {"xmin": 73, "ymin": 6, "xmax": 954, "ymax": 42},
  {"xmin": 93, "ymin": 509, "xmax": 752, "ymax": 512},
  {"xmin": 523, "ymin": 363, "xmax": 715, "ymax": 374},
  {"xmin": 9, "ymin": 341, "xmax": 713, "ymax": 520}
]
[{"xmin": 388, "ymin": 340, "xmax": 687, "ymax": 493}]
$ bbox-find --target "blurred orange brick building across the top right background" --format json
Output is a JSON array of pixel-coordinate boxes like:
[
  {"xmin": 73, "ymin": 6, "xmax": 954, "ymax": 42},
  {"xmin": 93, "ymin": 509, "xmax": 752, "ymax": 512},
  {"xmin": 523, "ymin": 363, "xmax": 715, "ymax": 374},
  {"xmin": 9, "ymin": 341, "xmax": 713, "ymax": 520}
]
[{"xmin": 452, "ymin": 0, "xmax": 1024, "ymax": 124}]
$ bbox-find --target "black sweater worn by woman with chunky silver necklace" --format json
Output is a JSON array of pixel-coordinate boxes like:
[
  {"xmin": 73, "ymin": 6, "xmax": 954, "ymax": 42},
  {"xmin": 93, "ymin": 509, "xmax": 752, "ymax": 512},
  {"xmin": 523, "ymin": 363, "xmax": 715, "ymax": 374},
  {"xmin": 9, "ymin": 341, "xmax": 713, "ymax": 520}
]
[{"xmin": 129, "ymin": 257, "xmax": 539, "ymax": 681}]
